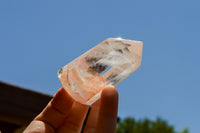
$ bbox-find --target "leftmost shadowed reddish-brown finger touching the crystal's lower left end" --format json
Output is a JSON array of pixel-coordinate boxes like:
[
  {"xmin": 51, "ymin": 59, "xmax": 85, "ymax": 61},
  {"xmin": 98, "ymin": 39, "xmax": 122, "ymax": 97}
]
[{"xmin": 32, "ymin": 88, "xmax": 74, "ymax": 130}]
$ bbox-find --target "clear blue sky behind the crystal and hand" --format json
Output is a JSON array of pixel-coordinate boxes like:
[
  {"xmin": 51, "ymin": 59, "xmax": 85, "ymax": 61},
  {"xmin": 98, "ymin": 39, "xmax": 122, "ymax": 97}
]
[{"xmin": 0, "ymin": 0, "xmax": 200, "ymax": 133}]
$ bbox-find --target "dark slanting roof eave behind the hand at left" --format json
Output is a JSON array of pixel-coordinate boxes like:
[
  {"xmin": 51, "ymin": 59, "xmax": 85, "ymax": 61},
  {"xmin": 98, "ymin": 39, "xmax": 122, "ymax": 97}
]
[{"xmin": 0, "ymin": 81, "xmax": 52, "ymax": 125}]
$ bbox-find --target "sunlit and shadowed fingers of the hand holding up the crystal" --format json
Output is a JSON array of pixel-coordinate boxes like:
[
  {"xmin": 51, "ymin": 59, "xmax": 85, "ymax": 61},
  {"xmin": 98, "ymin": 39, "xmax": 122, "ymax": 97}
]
[{"xmin": 24, "ymin": 86, "xmax": 118, "ymax": 133}]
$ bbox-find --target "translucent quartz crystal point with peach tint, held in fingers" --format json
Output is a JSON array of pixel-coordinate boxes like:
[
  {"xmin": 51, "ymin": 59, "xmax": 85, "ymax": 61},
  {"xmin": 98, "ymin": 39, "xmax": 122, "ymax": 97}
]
[{"xmin": 58, "ymin": 38, "xmax": 143, "ymax": 105}]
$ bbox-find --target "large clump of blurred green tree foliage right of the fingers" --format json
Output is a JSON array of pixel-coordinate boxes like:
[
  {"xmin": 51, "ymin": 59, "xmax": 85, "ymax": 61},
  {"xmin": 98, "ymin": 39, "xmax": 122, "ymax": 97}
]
[{"xmin": 117, "ymin": 118, "xmax": 176, "ymax": 133}]
